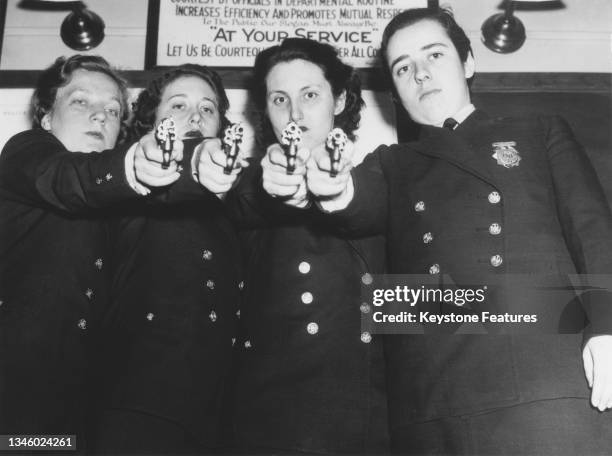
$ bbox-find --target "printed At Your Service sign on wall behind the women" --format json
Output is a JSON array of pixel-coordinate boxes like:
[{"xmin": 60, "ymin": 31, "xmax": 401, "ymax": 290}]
[{"xmin": 157, "ymin": 0, "xmax": 427, "ymax": 68}]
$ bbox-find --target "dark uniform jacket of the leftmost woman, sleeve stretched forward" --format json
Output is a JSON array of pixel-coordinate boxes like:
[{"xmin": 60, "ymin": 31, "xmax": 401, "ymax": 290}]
[{"xmin": 0, "ymin": 130, "xmax": 136, "ymax": 442}]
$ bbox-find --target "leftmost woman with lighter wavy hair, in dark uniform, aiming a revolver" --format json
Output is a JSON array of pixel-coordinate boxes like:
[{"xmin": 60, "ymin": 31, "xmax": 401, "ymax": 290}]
[{"xmin": 0, "ymin": 55, "xmax": 176, "ymax": 450}]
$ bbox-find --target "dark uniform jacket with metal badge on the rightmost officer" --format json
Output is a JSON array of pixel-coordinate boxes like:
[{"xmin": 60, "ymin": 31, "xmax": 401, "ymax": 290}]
[{"xmin": 332, "ymin": 111, "xmax": 612, "ymax": 448}]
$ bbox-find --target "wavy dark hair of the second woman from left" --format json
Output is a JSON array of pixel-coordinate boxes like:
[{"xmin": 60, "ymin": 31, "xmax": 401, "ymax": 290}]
[{"xmin": 128, "ymin": 63, "xmax": 230, "ymax": 141}]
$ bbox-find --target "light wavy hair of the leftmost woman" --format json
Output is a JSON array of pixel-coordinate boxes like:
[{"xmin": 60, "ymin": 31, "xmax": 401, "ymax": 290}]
[{"xmin": 31, "ymin": 54, "xmax": 128, "ymax": 143}]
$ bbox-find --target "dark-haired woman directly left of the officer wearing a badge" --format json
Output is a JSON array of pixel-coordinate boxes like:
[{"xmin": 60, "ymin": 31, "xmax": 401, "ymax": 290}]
[{"xmin": 227, "ymin": 38, "xmax": 387, "ymax": 453}]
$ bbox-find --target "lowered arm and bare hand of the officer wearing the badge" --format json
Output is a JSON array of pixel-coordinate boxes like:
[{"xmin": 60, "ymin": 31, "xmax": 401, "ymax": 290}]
[{"xmin": 545, "ymin": 117, "xmax": 612, "ymax": 411}]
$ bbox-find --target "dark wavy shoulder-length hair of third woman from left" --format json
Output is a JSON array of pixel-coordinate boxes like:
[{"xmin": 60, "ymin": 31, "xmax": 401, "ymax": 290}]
[{"xmin": 251, "ymin": 38, "xmax": 365, "ymax": 147}]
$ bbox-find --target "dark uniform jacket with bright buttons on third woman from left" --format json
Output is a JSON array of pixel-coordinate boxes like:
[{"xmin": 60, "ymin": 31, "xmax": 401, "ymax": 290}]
[{"xmin": 228, "ymin": 165, "xmax": 387, "ymax": 453}]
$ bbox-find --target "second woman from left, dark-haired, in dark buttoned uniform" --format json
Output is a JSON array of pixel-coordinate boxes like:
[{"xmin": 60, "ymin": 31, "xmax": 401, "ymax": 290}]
[{"xmin": 96, "ymin": 65, "xmax": 242, "ymax": 454}]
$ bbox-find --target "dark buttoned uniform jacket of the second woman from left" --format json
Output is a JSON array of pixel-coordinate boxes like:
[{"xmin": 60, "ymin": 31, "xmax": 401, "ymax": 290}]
[{"xmin": 99, "ymin": 136, "xmax": 243, "ymax": 448}]
